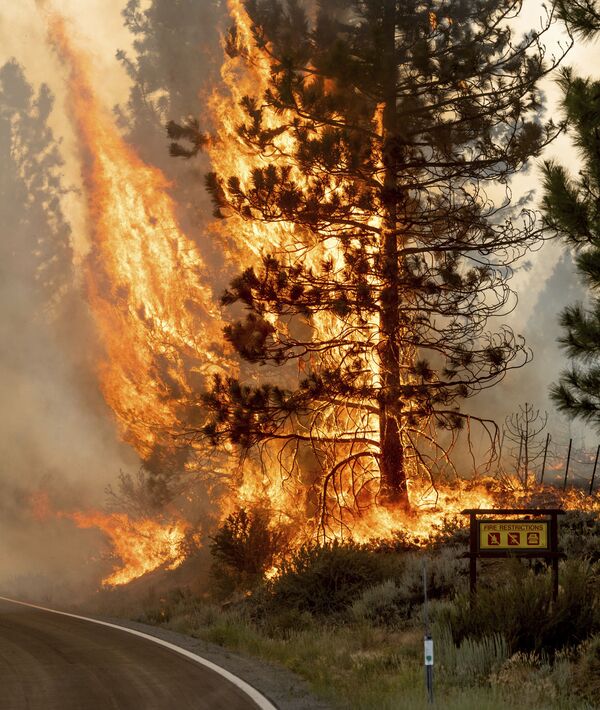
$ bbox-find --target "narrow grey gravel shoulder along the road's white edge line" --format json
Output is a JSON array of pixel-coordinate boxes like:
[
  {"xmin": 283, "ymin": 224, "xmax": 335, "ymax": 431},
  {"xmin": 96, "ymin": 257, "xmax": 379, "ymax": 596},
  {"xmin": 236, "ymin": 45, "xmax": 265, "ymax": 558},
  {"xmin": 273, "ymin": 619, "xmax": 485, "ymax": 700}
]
[{"xmin": 94, "ymin": 616, "xmax": 331, "ymax": 710}]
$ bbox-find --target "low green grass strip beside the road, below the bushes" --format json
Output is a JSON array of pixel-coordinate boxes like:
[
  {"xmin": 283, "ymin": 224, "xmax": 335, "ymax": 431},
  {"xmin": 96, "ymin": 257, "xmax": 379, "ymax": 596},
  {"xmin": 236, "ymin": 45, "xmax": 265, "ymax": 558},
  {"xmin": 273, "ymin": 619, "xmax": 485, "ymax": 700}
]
[{"xmin": 131, "ymin": 593, "xmax": 598, "ymax": 710}]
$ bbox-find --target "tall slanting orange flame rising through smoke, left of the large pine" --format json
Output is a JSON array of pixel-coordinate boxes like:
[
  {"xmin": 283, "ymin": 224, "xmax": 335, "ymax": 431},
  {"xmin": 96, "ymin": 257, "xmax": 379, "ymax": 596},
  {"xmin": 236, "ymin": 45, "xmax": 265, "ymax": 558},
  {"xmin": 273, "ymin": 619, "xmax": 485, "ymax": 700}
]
[{"xmin": 50, "ymin": 16, "xmax": 231, "ymax": 458}]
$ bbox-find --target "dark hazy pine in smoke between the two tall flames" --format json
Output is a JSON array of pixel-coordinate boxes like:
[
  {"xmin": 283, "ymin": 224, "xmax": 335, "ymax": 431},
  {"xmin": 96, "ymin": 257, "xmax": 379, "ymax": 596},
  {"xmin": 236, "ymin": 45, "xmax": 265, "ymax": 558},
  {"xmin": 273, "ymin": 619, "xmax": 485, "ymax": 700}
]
[{"xmin": 115, "ymin": 0, "xmax": 228, "ymax": 245}]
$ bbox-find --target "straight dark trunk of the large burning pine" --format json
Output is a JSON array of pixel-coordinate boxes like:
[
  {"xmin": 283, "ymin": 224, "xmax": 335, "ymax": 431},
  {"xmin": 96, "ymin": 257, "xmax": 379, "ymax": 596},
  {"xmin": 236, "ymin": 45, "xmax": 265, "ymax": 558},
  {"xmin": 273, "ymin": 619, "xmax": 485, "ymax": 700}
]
[{"xmin": 379, "ymin": 0, "xmax": 409, "ymax": 508}]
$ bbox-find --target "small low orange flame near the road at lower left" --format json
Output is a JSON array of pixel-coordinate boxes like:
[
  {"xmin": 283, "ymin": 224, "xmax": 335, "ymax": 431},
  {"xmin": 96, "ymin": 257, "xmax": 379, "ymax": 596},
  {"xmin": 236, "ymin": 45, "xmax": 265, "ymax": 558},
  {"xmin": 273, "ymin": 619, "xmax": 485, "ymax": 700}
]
[{"xmin": 30, "ymin": 492, "xmax": 189, "ymax": 587}]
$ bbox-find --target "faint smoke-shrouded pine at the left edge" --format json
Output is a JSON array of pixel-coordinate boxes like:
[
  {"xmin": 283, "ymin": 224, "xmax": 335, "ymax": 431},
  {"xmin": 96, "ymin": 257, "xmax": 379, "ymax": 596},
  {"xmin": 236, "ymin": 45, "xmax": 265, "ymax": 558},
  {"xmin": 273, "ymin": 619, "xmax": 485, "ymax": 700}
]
[{"xmin": 0, "ymin": 60, "xmax": 73, "ymax": 319}]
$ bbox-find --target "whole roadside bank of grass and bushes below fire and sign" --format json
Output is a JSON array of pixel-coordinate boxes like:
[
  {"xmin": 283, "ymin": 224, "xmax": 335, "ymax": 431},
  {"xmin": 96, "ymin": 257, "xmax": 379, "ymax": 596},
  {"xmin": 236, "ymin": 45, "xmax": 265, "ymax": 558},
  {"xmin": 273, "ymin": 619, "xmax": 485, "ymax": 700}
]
[{"xmin": 91, "ymin": 513, "xmax": 600, "ymax": 710}]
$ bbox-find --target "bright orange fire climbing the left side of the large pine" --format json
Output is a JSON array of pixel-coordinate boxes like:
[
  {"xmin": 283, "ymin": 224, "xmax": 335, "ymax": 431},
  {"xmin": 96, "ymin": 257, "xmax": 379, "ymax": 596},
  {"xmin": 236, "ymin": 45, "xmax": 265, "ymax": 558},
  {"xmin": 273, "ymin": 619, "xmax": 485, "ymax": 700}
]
[{"xmin": 206, "ymin": 0, "xmax": 487, "ymax": 539}]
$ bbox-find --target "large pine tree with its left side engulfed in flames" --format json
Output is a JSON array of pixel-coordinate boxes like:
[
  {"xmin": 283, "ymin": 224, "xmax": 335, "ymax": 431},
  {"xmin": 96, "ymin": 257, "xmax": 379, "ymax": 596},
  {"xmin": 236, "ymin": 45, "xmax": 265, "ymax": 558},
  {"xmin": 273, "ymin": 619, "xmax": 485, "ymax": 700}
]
[{"xmin": 170, "ymin": 0, "xmax": 568, "ymax": 530}]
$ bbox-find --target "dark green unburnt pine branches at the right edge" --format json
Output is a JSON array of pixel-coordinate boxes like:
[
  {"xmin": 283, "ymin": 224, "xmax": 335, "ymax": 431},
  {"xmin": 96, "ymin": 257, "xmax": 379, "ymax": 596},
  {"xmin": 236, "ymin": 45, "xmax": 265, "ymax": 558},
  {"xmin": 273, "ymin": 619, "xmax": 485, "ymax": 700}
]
[{"xmin": 544, "ymin": 69, "xmax": 600, "ymax": 425}]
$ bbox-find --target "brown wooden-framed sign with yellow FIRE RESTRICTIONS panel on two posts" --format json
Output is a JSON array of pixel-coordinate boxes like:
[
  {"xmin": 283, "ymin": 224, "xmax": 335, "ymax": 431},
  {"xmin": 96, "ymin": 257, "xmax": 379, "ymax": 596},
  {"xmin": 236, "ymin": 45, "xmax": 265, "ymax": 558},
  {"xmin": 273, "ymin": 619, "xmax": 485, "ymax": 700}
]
[{"xmin": 462, "ymin": 508, "xmax": 565, "ymax": 601}]
